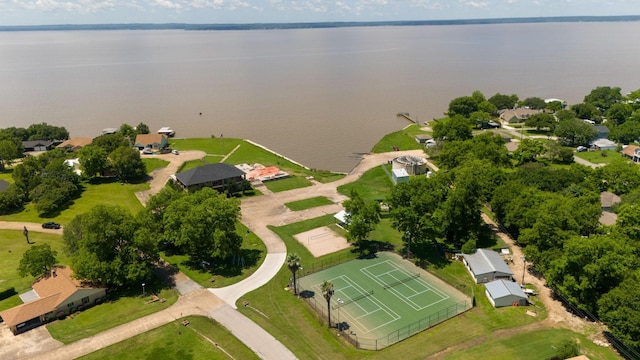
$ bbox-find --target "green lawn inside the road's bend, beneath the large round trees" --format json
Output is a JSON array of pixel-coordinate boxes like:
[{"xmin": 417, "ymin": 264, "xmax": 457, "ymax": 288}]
[{"xmin": 162, "ymin": 223, "xmax": 267, "ymax": 288}]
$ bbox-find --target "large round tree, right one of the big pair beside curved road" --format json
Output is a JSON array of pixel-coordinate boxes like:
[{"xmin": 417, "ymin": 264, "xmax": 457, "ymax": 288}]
[{"xmin": 162, "ymin": 188, "xmax": 242, "ymax": 262}]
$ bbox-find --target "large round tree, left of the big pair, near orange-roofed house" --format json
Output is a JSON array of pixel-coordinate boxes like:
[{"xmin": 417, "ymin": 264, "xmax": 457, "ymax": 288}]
[{"xmin": 63, "ymin": 205, "xmax": 159, "ymax": 286}]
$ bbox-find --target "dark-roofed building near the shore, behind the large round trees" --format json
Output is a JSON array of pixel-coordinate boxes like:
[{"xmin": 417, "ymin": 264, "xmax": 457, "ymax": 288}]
[{"xmin": 172, "ymin": 163, "xmax": 245, "ymax": 192}]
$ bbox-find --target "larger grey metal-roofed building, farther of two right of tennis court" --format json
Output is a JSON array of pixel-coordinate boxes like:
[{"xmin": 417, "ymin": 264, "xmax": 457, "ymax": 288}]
[{"xmin": 462, "ymin": 249, "xmax": 513, "ymax": 284}]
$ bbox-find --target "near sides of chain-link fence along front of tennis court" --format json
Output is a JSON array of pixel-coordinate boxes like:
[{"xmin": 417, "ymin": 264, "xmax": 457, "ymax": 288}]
[{"xmin": 300, "ymin": 290, "xmax": 473, "ymax": 350}]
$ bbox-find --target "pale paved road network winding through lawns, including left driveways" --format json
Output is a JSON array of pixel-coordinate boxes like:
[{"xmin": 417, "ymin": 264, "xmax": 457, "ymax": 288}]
[{"xmin": 0, "ymin": 150, "xmax": 430, "ymax": 360}]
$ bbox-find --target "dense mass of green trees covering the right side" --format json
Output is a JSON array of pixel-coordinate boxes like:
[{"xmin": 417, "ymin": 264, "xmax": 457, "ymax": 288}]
[{"xmin": 388, "ymin": 87, "xmax": 640, "ymax": 348}]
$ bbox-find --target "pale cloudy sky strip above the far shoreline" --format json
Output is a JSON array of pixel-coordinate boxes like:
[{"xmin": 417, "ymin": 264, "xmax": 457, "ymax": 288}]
[{"xmin": 0, "ymin": 0, "xmax": 640, "ymax": 26}]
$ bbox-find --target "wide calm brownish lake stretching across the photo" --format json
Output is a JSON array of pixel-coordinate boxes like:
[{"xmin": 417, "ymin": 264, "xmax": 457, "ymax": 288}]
[{"xmin": 0, "ymin": 22, "xmax": 640, "ymax": 171}]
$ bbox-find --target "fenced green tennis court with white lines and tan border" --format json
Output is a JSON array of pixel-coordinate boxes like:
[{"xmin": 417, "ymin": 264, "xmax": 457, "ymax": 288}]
[{"xmin": 299, "ymin": 252, "xmax": 472, "ymax": 349}]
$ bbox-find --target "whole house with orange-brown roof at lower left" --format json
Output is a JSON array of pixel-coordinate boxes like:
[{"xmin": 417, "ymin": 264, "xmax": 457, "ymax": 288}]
[{"xmin": 0, "ymin": 267, "xmax": 106, "ymax": 335}]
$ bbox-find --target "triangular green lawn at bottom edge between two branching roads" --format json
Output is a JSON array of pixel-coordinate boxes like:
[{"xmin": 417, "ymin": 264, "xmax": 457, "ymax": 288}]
[{"xmin": 80, "ymin": 316, "xmax": 259, "ymax": 360}]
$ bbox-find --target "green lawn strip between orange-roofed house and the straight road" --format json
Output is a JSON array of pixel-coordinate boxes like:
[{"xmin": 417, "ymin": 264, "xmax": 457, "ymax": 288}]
[{"xmin": 47, "ymin": 286, "xmax": 178, "ymax": 344}]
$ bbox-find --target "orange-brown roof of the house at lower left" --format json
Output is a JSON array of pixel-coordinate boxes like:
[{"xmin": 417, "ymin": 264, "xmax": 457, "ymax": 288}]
[{"xmin": 0, "ymin": 267, "xmax": 102, "ymax": 326}]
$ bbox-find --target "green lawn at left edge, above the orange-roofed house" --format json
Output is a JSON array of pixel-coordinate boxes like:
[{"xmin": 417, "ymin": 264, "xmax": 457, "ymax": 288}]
[{"xmin": 0, "ymin": 229, "xmax": 69, "ymax": 310}]
